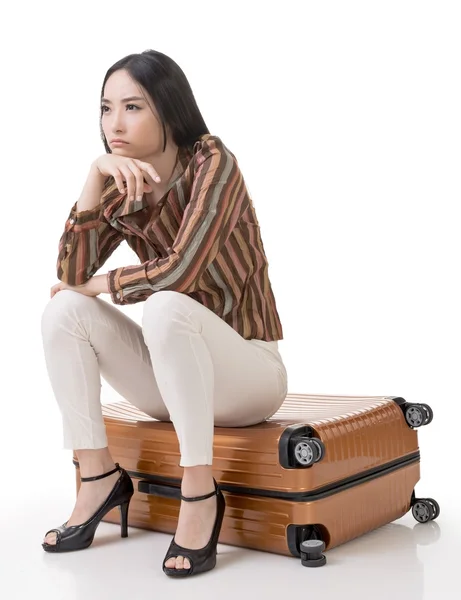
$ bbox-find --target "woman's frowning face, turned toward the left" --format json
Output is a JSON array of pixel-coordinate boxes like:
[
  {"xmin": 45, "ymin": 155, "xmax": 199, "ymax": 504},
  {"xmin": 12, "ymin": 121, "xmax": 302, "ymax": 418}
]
[{"xmin": 101, "ymin": 70, "xmax": 167, "ymax": 160}]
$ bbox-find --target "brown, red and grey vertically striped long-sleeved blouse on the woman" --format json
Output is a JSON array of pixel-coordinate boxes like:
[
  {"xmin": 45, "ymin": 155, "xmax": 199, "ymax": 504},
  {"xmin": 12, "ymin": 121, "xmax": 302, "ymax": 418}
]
[{"xmin": 57, "ymin": 134, "xmax": 283, "ymax": 341}]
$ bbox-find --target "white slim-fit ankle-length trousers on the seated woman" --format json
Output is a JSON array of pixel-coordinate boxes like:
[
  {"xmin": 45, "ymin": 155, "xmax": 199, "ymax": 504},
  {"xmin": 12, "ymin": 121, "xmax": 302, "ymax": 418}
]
[{"xmin": 41, "ymin": 290, "xmax": 287, "ymax": 467}]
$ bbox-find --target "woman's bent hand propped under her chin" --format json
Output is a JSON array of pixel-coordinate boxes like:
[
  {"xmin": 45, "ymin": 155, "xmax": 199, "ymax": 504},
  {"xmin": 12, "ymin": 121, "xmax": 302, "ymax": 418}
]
[{"xmin": 92, "ymin": 154, "xmax": 160, "ymax": 200}]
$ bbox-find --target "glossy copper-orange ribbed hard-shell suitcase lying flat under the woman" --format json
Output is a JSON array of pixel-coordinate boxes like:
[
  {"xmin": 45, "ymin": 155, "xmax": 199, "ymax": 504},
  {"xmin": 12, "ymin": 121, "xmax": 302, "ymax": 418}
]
[{"xmin": 74, "ymin": 394, "xmax": 440, "ymax": 566}]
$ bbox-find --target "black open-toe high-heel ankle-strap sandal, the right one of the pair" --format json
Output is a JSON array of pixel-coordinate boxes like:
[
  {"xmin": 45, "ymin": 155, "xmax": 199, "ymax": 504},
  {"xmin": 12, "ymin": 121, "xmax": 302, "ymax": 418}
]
[{"xmin": 163, "ymin": 479, "xmax": 226, "ymax": 577}]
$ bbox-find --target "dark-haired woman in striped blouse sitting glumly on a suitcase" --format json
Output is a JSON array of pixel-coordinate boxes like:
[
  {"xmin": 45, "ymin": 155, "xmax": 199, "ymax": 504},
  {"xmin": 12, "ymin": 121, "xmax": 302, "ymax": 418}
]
[{"xmin": 42, "ymin": 50, "xmax": 287, "ymax": 576}]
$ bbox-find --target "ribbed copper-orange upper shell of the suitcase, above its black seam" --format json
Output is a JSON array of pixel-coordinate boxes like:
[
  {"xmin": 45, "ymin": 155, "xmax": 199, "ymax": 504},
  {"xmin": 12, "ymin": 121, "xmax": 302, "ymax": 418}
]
[{"xmin": 99, "ymin": 394, "xmax": 418, "ymax": 492}]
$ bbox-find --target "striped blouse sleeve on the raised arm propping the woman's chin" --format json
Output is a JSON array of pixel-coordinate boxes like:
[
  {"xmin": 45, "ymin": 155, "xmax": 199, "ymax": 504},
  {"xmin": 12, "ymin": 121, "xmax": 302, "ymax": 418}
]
[{"xmin": 56, "ymin": 202, "xmax": 123, "ymax": 285}]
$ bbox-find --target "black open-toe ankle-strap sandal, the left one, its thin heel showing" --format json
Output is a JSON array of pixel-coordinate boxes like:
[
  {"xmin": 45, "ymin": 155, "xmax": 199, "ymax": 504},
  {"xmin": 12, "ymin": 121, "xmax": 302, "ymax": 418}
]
[{"xmin": 42, "ymin": 463, "xmax": 134, "ymax": 552}]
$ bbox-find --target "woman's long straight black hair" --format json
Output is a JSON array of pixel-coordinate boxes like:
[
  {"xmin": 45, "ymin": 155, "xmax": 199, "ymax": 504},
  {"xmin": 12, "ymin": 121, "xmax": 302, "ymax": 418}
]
[{"xmin": 99, "ymin": 50, "xmax": 210, "ymax": 153}]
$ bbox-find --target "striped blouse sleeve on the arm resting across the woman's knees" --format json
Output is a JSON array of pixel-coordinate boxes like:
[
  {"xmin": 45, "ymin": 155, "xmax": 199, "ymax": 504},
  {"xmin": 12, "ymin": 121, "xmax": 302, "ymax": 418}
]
[{"xmin": 108, "ymin": 139, "xmax": 248, "ymax": 304}]
